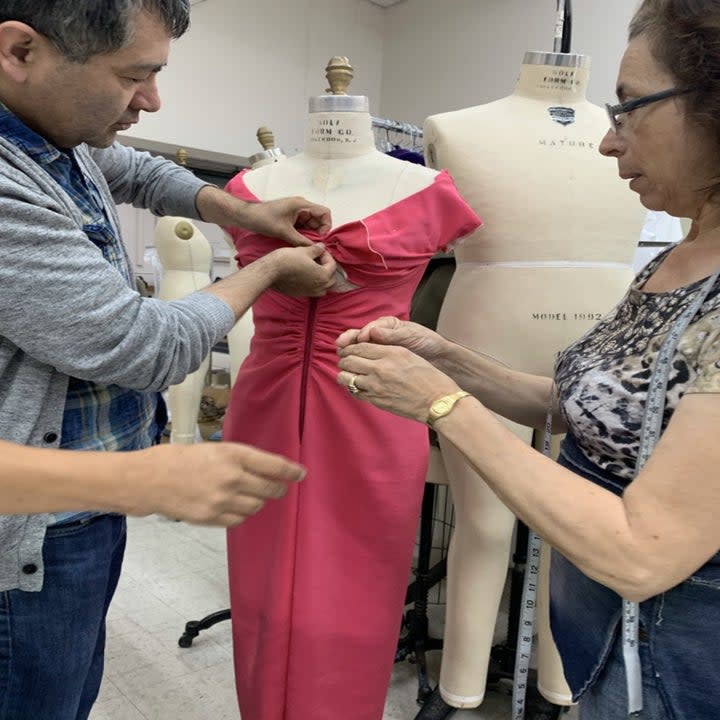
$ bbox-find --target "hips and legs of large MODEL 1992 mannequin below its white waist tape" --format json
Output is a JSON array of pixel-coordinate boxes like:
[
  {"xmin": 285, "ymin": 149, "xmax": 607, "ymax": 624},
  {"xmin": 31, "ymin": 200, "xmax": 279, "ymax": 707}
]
[{"xmin": 438, "ymin": 263, "xmax": 631, "ymax": 707}]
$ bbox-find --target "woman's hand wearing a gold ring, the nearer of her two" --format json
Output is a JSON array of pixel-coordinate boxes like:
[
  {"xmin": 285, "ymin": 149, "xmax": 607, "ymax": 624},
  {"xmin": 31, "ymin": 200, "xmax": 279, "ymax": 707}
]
[{"xmin": 337, "ymin": 342, "xmax": 459, "ymax": 423}]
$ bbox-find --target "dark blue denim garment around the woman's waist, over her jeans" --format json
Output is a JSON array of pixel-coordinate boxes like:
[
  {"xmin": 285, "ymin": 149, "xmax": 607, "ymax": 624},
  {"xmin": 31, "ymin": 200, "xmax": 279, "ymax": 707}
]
[{"xmin": 550, "ymin": 435, "xmax": 720, "ymax": 720}]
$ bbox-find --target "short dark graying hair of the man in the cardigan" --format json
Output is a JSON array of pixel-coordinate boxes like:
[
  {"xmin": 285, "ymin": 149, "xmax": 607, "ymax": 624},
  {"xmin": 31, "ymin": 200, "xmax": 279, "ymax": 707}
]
[{"xmin": 0, "ymin": 0, "xmax": 190, "ymax": 63}]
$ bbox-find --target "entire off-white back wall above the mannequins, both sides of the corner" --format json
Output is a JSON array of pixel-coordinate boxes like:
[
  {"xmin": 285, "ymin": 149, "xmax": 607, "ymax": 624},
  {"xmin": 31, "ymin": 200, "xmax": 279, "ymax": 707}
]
[{"xmin": 121, "ymin": 0, "xmax": 636, "ymax": 157}]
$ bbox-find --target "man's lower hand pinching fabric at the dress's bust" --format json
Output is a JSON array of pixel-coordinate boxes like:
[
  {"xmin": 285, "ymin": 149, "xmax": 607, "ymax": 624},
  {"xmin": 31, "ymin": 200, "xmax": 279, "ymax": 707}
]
[{"xmin": 265, "ymin": 243, "xmax": 336, "ymax": 297}]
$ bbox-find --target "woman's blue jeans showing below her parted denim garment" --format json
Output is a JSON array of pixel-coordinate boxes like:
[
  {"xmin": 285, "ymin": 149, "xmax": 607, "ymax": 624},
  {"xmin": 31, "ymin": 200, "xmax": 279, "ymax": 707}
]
[{"xmin": 580, "ymin": 637, "xmax": 676, "ymax": 720}]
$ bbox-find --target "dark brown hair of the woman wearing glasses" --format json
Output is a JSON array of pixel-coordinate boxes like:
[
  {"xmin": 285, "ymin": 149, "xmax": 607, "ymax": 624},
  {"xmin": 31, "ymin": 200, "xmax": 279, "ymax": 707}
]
[{"xmin": 629, "ymin": 0, "xmax": 720, "ymax": 196}]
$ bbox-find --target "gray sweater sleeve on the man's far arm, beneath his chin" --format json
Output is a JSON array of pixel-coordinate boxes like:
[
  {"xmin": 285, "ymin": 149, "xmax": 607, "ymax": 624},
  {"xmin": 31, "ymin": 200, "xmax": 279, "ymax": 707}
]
[{"xmin": 87, "ymin": 142, "xmax": 208, "ymax": 220}]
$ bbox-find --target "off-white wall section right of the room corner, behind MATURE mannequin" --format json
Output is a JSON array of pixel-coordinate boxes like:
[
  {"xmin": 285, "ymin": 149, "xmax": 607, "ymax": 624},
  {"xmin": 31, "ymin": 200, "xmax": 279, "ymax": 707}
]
[{"xmin": 381, "ymin": 0, "xmax": 637, "ymax": 125}]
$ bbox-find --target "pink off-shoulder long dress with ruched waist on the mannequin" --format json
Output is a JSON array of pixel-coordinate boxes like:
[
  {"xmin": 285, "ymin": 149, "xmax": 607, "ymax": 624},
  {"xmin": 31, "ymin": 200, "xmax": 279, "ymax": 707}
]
[{"xmin": 223, "ymin": 167, "xmax": 480, "ymax": 720}]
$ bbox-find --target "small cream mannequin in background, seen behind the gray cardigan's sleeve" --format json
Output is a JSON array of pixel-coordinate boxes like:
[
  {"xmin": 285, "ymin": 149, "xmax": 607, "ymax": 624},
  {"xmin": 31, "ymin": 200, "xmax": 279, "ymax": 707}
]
[{"xmin": 155, "ymin": 216, "xmax": 212, "ymax": 445}]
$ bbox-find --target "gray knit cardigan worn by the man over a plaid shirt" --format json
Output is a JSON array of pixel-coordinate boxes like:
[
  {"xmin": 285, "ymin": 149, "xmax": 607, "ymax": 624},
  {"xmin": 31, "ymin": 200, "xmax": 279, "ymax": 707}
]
[{"xmin": 0, "ymin": 137, "xmax": 235, "ymax": 591}]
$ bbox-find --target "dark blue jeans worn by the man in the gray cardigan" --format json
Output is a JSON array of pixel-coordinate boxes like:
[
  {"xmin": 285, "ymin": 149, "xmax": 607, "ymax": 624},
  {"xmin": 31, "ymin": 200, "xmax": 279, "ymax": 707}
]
[{"xmin": 0, "ymin": 515, "xmax": 126, "ymax": 720}]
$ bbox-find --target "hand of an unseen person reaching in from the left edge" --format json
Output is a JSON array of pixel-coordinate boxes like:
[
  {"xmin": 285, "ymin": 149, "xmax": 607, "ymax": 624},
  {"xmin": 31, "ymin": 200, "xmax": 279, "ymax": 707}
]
[{"xmin": 124, "ymin": 442, "xmax": 305, "ymax": 527}]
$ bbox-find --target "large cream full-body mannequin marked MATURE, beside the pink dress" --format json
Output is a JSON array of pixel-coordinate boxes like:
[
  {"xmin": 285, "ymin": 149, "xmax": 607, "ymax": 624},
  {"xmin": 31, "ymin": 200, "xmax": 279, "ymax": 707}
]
[{"xmin": 418, "ymin": 52, "xmax": 644, "ymax": 717}]
